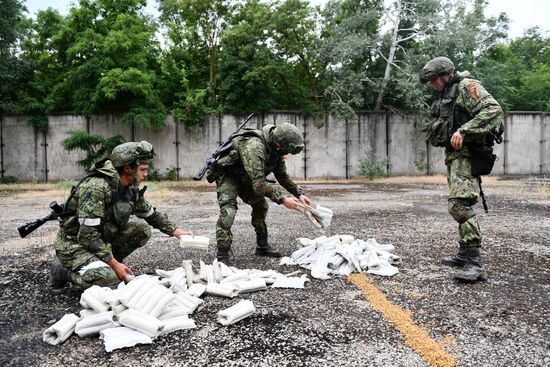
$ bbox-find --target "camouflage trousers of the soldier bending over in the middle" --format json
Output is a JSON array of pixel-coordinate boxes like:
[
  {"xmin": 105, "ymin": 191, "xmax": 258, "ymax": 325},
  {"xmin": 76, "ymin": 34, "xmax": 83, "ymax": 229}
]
[{"xmin": 216, "ymin": 175, "xmax": 269, "ymax": 248}]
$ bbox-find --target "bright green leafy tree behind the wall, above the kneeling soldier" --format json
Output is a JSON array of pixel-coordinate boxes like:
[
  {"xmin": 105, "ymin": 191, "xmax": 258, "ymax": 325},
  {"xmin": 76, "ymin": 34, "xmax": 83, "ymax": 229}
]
[{"xmin": 51, "ymin": 0, "xmax": 166, "ymax": 130}]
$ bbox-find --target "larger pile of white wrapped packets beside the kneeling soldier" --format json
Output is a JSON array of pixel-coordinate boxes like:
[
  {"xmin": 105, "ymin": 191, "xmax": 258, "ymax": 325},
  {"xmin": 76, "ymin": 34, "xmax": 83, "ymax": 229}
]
[{"xmin": 43, "ymin": 260, "xmax": 308, "ymax": 352}]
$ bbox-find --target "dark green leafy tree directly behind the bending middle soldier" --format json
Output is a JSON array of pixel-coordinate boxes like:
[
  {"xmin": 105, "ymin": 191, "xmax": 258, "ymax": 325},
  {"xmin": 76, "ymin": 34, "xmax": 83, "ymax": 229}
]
[{"xmin": 220, "ymin": 0, "xmax": 319, "ymax": 114}]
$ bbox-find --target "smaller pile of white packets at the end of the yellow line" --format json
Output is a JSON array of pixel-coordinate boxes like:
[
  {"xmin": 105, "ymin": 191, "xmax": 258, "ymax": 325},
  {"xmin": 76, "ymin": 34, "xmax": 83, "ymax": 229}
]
[{"xmin": 280, "ymin": 235, "xmax": 401, "ymax": 279}]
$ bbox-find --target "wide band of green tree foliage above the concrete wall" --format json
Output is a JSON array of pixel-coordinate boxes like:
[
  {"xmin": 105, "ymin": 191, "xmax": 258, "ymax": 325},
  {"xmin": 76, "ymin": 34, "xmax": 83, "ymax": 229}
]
[{"xmin": 4, "ymin": 0, "xmax": 550, "ymax": 130}]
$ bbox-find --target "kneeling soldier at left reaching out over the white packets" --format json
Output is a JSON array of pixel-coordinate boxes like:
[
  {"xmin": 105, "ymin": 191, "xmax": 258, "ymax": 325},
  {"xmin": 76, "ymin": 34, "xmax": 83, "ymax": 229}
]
[{"xmin": 48, "ymin": 141, "xmax": 192, "ymax": 294}]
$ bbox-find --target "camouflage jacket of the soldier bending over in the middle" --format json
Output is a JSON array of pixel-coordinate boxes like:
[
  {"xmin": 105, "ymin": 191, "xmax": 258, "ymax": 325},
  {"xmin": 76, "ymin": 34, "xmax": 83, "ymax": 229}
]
[{"xmin": 233, "ymin": 125, "xmax": 303, "ymax": 204}]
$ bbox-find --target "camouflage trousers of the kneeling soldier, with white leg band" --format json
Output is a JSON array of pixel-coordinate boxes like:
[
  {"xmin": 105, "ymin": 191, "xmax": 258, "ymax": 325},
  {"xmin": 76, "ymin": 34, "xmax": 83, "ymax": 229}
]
[{"xmin": 54, "ymin": 222, "xmax": 151, "ymax": 289}]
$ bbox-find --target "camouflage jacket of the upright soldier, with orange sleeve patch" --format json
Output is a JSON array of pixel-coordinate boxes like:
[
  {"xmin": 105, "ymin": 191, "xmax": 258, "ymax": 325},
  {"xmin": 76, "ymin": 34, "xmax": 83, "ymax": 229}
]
[{"xmin": 432, "ymin": 71, "xmax": 502, "ymax": 159}]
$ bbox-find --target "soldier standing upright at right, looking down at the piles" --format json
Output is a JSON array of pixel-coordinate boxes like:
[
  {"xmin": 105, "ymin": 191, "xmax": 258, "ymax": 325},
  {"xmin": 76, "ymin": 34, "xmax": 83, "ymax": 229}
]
[{"xmin": 419, "ymin": 57, "xmax": 502, "ymax": 281}]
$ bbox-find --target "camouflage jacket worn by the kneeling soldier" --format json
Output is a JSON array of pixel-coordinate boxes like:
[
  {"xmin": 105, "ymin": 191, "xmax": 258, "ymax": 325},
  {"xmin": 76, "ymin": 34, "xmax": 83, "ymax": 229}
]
[{"xmin": 60, "ymin": 160, "xmax": 176, "ymax": 261}]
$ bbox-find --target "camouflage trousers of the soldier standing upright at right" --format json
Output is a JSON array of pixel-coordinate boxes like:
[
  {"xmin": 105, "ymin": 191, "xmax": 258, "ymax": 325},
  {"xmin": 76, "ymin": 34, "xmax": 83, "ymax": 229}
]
[{"xmin": 445, "ymin": 157, "xmax": 481, "ymax": 248}]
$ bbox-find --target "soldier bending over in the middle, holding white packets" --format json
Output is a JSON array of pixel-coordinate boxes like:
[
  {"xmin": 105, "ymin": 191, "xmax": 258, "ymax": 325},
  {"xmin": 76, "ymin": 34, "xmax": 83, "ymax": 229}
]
[{"xmin": 211, "ymin": 123, "xmax": 311, "ymax": 261}]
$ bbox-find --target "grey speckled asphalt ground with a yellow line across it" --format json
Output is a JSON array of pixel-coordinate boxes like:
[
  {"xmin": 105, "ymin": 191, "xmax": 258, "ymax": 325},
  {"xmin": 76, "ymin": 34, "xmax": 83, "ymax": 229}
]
[{"xmin": 0, "ymin": 177, "xmax": 550, "ymax": 366}]
